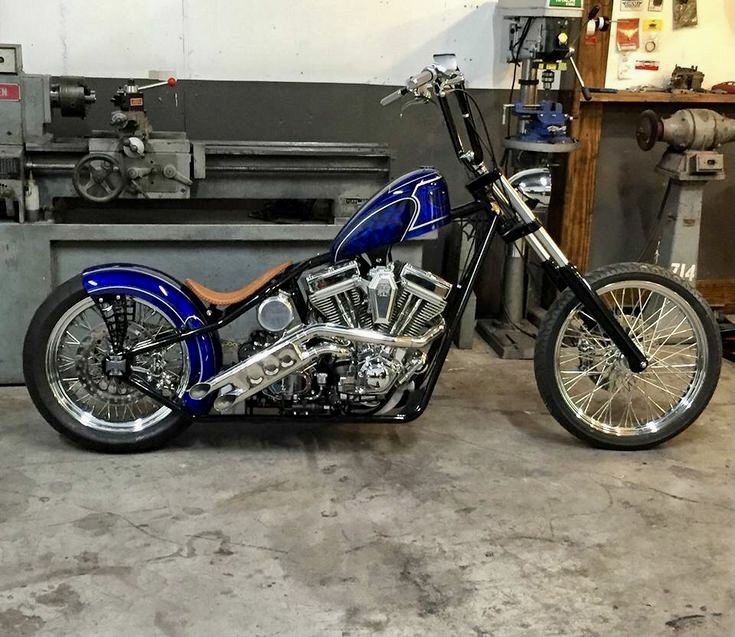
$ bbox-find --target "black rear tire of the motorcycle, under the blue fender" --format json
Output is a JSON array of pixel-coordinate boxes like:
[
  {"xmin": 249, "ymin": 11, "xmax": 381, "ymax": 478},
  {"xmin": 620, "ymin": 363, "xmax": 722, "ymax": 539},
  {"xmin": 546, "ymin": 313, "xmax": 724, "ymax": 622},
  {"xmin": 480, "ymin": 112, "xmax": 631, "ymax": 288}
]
[{"xmin": 23, "ymin": 276, "xmax": 191, "ymax": 453}]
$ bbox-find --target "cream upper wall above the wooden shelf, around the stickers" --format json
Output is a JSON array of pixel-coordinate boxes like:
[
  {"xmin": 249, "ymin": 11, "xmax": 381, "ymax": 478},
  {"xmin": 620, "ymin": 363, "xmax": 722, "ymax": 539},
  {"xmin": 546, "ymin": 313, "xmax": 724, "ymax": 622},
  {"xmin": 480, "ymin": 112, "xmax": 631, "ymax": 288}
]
[{"xmin": 606, "ymin": 0, "xmax": 735, "ymax": 88}]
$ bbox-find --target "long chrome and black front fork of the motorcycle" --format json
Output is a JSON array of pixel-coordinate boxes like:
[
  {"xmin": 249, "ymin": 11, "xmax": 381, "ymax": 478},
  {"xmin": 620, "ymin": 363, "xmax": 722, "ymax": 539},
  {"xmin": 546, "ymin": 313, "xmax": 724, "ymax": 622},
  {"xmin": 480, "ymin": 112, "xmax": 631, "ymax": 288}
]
[{"xmin": 490, "ymin": 172, "xmax": 648, "ymax": 373}]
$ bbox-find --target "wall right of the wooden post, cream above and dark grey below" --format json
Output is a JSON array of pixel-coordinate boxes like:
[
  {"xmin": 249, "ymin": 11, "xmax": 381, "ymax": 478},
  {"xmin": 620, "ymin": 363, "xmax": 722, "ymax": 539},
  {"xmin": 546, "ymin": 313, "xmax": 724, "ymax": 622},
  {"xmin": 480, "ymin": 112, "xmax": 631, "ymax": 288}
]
[{"xmin": 590, "ymin": 0, "xmax": 735, "ymax": 279}]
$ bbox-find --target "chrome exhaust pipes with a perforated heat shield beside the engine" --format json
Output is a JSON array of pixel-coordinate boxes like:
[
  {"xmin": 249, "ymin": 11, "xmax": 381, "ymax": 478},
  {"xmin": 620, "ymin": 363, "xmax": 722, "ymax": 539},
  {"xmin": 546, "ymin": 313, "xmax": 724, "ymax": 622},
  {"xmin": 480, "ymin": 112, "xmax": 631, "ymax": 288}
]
[{"xmin": 189, "ymin": 323, "xmax": 444, "ymax": 411}]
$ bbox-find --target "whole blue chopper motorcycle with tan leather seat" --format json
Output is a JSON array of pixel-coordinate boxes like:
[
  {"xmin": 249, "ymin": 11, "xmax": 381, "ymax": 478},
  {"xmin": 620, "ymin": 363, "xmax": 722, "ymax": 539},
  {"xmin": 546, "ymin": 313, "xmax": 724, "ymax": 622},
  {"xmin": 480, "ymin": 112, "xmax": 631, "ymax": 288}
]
[{"xmin": 24, "ymin": 55, "xmax": 721, "ymax": 452}]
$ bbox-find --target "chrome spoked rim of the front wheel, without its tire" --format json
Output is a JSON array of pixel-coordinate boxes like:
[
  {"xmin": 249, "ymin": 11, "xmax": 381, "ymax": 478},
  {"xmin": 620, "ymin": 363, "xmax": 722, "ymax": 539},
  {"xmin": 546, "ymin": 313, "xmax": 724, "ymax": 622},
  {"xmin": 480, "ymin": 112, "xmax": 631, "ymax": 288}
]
[{"xmin": 554, "ymin": 281, "xmax": 708, "ymax": 437}]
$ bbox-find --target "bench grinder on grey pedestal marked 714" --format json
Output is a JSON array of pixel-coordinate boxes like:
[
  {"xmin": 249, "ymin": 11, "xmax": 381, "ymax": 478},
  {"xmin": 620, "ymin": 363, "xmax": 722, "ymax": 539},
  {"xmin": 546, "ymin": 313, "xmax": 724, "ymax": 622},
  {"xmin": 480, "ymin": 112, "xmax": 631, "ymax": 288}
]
[{"xmin": 636, "ymin": 108, "xmax": 735, "ymax": 283}]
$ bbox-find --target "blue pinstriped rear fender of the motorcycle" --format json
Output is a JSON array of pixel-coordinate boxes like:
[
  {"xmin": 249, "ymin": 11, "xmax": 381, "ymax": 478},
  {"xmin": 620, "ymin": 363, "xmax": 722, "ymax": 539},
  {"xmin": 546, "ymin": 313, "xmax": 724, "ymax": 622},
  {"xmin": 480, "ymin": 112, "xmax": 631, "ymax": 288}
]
[{"xmin": 82, "ymin": 263, "xmax": 220, "ymax": 414}]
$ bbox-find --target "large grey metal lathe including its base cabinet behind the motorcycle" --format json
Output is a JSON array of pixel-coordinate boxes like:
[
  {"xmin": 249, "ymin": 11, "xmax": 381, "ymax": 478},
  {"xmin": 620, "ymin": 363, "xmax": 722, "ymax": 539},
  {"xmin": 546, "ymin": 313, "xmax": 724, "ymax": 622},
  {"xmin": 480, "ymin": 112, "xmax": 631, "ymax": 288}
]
[{"xmin": 0, "ymin": 44, "xmax": 412, "ymax": 383}]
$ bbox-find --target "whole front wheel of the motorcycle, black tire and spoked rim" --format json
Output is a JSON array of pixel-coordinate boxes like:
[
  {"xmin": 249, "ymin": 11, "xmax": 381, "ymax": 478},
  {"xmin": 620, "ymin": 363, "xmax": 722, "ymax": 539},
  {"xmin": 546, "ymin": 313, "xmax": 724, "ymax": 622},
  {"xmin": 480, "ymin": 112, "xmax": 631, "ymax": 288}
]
[{"xmin": 534, "ymin": 263, "xmax": 722, "ymax": 449}]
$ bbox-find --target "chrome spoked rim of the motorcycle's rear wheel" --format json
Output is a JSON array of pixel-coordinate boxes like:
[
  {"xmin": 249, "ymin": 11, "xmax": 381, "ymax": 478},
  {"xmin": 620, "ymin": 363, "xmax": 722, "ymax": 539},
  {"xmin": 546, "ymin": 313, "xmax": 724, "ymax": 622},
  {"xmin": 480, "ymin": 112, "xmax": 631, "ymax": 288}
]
[{"xmin": 45, "ymin": 297, "xmax": 189, "ymax": 433}]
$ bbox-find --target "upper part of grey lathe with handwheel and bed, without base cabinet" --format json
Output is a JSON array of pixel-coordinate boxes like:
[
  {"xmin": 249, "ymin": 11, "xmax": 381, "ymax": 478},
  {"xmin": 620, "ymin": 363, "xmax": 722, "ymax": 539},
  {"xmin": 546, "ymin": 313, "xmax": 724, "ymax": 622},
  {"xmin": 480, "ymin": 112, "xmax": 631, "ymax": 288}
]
[{"xmin": 0, "ymin": 44, "xmax": 390, "ymax": 222}]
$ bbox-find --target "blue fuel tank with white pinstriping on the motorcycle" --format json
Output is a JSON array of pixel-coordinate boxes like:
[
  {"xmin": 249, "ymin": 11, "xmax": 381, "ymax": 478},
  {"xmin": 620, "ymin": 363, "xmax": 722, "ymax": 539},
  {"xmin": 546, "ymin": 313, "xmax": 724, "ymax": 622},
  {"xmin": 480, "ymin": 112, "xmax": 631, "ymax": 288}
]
[{"xmin": 331, "ymin": 168, "xmax": 449, "ymax": 262}]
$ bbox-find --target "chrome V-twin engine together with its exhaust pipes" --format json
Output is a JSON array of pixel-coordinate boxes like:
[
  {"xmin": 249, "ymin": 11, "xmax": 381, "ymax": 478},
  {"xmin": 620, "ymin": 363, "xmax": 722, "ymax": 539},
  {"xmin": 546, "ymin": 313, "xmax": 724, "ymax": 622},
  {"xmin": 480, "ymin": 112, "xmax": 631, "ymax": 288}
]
[{"xmin": 201, "ymin": 261, "xmax": 452, "ymax": 413}]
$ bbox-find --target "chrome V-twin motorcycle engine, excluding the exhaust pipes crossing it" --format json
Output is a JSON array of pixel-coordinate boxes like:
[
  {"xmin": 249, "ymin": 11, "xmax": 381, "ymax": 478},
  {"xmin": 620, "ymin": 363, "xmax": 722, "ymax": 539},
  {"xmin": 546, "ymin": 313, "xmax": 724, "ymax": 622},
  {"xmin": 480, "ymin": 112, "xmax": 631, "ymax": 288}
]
[{"xmin": 239, "ymin": 261, "xmax": 452, "ymax": 413}]
